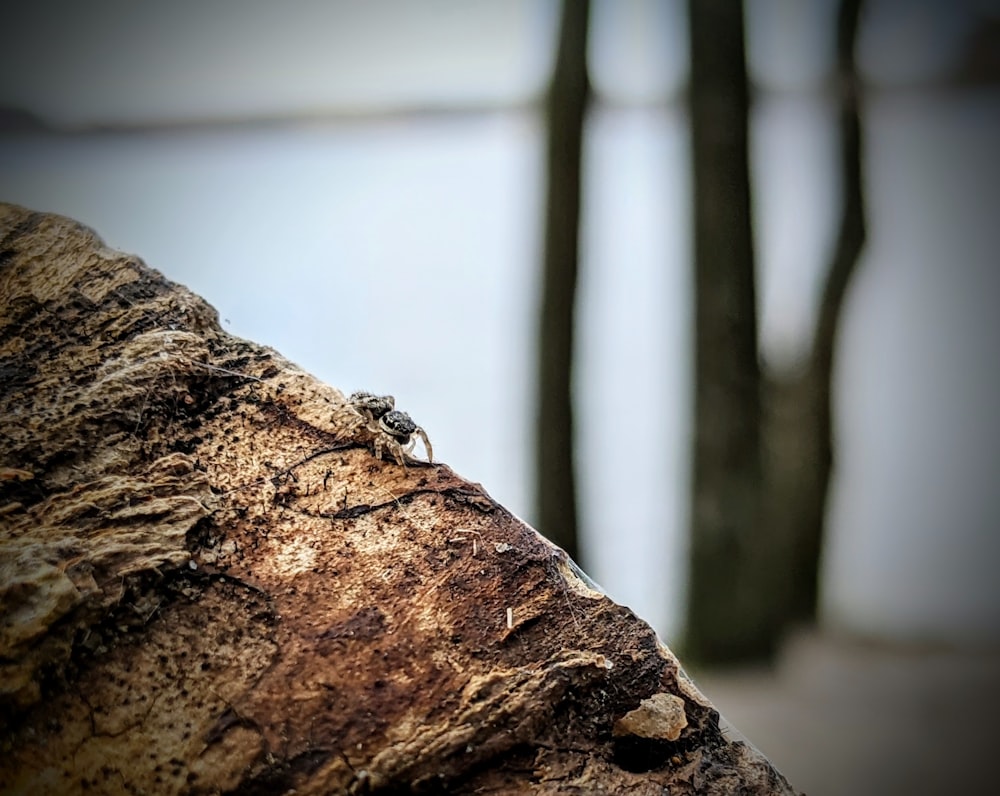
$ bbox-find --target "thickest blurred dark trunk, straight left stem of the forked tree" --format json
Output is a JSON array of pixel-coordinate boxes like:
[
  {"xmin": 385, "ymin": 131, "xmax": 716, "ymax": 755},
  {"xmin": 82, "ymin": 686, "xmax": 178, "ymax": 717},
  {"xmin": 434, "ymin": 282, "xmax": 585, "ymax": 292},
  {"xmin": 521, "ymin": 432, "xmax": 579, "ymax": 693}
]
[{"xmin": 685, "ymin": 0, "xmax": 772, "ymax": 663}]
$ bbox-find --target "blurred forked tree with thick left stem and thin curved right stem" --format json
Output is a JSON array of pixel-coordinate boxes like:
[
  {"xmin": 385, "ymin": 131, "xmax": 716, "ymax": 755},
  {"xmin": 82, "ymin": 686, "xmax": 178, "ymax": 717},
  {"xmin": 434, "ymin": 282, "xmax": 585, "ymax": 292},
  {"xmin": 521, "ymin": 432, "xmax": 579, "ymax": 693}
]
[{"xmin": 687, "ymin": 0, "xmax": 865, "ymax": 663}]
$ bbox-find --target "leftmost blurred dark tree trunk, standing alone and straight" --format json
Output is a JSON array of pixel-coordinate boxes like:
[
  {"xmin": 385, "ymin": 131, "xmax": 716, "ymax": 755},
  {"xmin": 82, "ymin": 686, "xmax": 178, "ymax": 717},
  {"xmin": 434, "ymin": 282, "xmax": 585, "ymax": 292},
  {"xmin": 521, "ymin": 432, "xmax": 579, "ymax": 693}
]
[{"xmin": 536, "ymin": 0, "xmax": 590, "ymax": 558}]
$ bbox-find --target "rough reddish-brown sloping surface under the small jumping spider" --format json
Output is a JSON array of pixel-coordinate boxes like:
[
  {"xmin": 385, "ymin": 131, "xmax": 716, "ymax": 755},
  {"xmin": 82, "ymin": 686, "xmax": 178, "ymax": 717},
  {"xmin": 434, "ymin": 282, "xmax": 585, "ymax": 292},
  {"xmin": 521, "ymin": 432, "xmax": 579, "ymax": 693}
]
[{"xmin": 0, "ymin": 205, "xmax": 792, "ymax": 794}]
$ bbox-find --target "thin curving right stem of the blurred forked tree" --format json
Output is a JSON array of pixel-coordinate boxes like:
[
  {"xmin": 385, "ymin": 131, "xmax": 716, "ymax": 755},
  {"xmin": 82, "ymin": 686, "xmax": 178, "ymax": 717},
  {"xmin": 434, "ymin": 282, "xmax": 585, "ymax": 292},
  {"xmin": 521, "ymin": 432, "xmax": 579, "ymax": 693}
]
[{"xmin": 768, "ymin": 0, "xmax": 866, "ymax": 623}]
